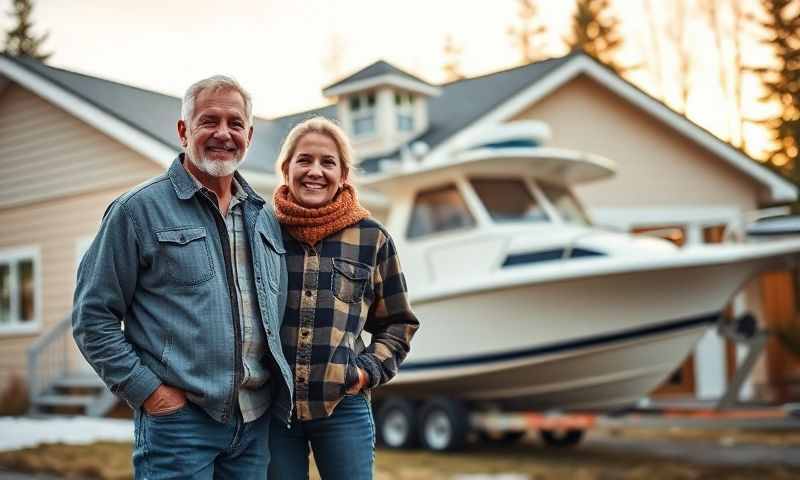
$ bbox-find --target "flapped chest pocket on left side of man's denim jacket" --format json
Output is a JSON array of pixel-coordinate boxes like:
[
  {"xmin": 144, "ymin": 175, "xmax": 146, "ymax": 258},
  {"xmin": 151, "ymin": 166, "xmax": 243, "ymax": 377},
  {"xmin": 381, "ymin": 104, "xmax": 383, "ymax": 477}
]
[{"xmin": 156, "ymin": 227, "xmax": 214, "ymax": 286}]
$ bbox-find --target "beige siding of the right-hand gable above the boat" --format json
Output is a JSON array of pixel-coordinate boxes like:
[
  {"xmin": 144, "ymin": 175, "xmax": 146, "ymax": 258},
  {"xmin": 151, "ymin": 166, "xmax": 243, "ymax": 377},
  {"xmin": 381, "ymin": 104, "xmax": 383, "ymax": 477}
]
[{"xmin": 516, "ymin": 76, "xmax": 762, "ymax": 210}]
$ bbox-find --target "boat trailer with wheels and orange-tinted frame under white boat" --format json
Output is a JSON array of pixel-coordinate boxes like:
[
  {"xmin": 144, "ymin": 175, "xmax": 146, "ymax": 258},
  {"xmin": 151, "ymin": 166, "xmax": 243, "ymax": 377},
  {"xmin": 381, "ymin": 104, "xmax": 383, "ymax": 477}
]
[{"xmin": 374, "ymin": 313, "xmax": 800, "ymax": 451}]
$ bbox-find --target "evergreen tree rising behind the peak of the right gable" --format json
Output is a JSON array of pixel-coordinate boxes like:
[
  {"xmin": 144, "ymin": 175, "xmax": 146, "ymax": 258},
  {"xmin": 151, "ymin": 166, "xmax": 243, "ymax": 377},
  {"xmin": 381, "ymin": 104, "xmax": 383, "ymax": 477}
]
[{"xmin": 566, "ymin": 0, "xmax": 624, "ymax": 73}]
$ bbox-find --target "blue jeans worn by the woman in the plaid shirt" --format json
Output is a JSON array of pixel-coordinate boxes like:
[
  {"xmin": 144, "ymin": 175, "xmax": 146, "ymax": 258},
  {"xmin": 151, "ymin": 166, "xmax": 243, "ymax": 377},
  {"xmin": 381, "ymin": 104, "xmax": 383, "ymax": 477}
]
[{"xmin": 269, "ymin": 393, "xmax": 375, "ymax": 480}]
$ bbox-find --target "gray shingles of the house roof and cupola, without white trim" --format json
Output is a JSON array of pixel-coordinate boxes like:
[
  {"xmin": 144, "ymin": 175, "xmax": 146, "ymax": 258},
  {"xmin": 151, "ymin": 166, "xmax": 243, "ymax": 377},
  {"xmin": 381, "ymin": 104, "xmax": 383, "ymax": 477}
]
[{"xmin": 6, "ymin": 57, "xmax": 569, "ymax": 172}]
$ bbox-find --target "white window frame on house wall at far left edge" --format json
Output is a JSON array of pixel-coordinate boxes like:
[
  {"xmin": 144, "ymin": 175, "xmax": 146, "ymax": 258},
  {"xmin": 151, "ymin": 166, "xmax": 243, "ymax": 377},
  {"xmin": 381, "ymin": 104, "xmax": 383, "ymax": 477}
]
[{"xmin": 0, "ymin": 246, "xmax": 43, "ymax": 336}]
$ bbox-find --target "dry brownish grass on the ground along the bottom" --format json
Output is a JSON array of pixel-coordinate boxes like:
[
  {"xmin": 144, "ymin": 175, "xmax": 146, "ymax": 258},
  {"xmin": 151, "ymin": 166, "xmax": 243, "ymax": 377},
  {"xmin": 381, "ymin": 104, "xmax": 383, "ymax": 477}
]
[{"xmin": 0, "ymin": 430, "xmax": 800, "ymax": 480}]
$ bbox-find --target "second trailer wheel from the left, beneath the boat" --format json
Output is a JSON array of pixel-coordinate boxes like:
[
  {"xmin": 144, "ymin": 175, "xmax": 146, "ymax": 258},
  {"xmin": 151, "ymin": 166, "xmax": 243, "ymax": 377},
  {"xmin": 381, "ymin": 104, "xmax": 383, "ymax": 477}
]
[{"xmin": 418, "ymin": 397, "xmax": 469, "ymax": 452}]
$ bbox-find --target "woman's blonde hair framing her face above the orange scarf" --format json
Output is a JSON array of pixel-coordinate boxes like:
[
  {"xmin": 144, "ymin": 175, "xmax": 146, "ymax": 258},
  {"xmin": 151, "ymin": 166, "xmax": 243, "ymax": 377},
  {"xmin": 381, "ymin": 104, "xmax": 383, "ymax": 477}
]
[{"xmin": 275, "ymin": 117, "xmax": 353, "ymax": 183}]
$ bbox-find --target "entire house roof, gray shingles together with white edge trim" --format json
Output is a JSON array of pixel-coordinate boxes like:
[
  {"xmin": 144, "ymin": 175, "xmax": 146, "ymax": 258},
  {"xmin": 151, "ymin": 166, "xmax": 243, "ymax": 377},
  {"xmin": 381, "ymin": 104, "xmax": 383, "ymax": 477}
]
[{"xmin": 0, "ymin": 53, "xmax": 797, "ymax": 202}]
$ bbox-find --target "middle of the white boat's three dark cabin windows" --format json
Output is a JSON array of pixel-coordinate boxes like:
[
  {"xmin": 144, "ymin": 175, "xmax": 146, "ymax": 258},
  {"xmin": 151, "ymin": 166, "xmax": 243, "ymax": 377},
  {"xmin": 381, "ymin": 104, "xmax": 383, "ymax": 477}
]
[{"xmin": 470, "ymin": 178, "xmax": 548, "ymax": 223}]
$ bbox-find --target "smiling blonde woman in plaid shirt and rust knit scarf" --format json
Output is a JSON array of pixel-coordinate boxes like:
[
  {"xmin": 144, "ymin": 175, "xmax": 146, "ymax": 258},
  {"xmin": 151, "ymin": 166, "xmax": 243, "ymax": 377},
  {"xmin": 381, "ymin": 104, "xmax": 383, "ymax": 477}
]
[{"xmin": 269, "ymin": 117, "xmax": 419, "ymax": 480}]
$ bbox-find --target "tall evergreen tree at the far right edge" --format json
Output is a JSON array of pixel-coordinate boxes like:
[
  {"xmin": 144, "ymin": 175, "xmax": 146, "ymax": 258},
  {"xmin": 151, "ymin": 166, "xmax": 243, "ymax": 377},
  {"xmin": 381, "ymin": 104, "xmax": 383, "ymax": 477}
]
[{"xmin": 756, "ymin": 0, "xmax": 800, "ymax": 183}]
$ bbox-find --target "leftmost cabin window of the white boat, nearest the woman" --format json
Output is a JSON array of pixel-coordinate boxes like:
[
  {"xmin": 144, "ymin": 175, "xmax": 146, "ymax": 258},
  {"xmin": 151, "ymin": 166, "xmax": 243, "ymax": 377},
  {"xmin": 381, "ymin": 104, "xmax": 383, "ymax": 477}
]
[{"xmin": 407, "ymin": 185, "xmax": 475, "ymax": 238}]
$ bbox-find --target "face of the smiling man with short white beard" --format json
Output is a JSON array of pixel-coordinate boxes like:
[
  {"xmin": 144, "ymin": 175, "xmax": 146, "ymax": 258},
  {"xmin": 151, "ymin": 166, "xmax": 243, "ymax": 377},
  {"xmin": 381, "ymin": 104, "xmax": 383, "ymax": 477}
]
[{"xmin": 178, "ymin": 89, "xmax": 253, "ymax": 177}]
